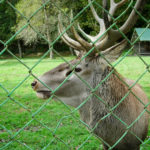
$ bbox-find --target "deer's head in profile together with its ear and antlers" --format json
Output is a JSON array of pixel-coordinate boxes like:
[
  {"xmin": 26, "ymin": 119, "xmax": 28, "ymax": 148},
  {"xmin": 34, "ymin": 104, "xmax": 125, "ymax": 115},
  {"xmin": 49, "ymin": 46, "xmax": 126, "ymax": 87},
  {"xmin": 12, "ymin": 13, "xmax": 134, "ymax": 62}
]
[{"xmin": 32, "ymin": 0, "xmax": 144, "ymax": 107}]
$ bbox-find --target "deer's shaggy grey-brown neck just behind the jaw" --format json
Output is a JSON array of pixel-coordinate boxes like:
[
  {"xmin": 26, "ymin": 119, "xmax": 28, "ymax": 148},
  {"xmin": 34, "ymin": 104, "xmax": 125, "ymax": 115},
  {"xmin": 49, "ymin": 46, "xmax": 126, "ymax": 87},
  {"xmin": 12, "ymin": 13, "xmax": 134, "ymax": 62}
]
[{"xmin": 79, "ymin": 66, "xmax": 127, "ymax": 126}]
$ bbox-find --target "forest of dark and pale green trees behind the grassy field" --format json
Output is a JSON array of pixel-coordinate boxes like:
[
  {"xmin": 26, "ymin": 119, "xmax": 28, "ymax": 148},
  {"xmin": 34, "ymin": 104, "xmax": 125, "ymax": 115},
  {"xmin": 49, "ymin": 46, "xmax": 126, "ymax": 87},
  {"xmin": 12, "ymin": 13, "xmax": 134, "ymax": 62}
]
[{"xmin": 0, "ymin": 0, "xmax": 150, "ymax": 58}]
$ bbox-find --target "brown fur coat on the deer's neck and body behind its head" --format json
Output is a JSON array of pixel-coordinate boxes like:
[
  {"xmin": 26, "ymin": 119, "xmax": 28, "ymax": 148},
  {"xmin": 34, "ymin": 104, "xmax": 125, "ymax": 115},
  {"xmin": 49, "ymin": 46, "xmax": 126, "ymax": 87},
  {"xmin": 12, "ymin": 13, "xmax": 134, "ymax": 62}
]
[{"xmin": 84, "ymin": 67, "xmax": 149, "ymax": 150}]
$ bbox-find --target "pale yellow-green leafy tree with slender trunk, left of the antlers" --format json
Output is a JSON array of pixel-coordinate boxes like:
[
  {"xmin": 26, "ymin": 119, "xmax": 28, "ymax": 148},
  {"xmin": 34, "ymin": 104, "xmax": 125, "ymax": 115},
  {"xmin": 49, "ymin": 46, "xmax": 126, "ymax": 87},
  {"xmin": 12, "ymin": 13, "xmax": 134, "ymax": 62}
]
[{"xmin": 14, "ymin": 0, "xmax": 61, "ymax": 58}]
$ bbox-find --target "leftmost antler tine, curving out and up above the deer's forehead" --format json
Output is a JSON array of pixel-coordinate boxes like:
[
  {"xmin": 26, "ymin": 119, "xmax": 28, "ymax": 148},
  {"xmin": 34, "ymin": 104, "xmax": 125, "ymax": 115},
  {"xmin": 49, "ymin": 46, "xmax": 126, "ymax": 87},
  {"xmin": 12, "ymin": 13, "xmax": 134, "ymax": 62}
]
[{"xmin": 58, "ymin": 14, "xmax": 85, "ymax": 51}]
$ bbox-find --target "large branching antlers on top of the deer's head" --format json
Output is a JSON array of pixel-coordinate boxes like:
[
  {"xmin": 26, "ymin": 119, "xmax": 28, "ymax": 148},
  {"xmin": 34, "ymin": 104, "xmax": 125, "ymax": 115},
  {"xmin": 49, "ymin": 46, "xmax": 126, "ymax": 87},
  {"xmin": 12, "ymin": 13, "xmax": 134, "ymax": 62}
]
[{"xmin": 58, "ymin": 0, "xmax": 145, "ymax": 53}]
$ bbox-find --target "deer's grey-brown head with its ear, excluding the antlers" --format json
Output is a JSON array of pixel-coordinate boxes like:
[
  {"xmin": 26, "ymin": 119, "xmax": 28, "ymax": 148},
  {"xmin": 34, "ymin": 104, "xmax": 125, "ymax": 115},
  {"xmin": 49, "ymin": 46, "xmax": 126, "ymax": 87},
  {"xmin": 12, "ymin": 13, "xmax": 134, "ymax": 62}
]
[{"xmin": 32, "ymin": 41, "xmax": 126, "ymax": 107}]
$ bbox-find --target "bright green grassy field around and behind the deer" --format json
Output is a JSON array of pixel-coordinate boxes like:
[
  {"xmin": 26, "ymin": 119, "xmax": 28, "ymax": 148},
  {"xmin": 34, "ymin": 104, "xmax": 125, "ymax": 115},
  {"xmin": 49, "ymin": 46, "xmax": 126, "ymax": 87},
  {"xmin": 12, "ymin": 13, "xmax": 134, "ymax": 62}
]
[{"xmin": 0, "ymin": 57, "xmax": 150, "ymax": 150}]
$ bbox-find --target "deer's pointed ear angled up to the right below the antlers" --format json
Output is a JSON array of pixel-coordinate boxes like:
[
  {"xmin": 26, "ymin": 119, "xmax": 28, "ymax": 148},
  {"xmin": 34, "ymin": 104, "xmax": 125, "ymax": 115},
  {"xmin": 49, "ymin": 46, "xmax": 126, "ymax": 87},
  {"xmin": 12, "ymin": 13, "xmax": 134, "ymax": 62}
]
[{"xmin": 101, "ymin": 40, "xmax": 127, "ymax": 62}]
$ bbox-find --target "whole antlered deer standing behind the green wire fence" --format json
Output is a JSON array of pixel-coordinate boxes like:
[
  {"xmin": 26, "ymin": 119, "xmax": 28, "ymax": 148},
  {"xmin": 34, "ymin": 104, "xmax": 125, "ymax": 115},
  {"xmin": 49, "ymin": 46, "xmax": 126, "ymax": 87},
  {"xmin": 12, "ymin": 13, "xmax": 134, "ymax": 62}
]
[{"xmin": 31, "ymin": 0, "xmax": 150, "ymax": 150}]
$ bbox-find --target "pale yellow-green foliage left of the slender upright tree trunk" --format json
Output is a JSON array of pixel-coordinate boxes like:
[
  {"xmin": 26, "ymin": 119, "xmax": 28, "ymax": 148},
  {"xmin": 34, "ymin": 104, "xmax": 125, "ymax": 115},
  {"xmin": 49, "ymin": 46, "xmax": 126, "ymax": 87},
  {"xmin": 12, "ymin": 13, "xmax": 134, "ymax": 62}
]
[{"xmin": 14, "ymin": 0, "xmax": 44, "ymax": 44}]
